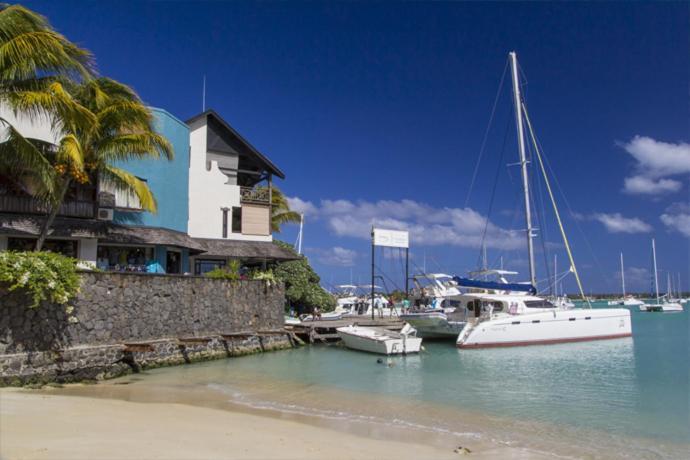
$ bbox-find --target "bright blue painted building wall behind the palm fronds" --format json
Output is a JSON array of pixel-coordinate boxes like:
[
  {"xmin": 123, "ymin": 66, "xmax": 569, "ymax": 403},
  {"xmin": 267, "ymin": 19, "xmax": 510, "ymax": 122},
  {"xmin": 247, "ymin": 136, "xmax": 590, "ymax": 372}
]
[{"xmin": 114, "ymin": 108, "xmax": 189, "ymax": 234}]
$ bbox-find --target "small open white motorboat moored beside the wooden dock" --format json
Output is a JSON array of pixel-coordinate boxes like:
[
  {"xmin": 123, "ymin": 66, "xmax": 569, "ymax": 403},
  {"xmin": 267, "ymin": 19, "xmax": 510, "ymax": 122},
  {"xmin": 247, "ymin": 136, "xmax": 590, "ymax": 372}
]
[{"xmin": 336, "ymin": 324, "xmax": 422, "ymax": 355}]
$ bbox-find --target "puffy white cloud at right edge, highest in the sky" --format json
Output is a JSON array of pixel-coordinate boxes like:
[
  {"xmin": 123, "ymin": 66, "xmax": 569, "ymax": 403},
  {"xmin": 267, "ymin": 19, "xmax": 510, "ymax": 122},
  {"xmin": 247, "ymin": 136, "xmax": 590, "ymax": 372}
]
[{"xmin": 621, "ymin": 136, "xmax": 690, "ymax": 195}]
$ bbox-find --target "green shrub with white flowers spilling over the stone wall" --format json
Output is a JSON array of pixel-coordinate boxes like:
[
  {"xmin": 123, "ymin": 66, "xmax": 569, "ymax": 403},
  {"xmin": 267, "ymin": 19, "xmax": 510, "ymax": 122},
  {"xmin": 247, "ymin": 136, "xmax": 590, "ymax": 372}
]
[{"xmin": 0, "ymin": 251, "xmax": 80, "ymax": 313}]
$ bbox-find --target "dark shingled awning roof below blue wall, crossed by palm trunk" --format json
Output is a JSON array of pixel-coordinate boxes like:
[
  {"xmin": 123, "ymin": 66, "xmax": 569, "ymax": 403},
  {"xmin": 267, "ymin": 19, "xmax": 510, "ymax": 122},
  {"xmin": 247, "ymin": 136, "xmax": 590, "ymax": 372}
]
[{"xmin": 0, "ymin": 214, "xmax": 204, "ymax": 253}]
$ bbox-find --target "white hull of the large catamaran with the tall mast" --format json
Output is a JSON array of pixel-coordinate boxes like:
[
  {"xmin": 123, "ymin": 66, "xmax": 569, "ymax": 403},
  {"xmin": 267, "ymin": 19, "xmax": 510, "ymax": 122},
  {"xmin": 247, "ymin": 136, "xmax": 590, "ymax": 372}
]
[{"xmin": 456, "ymin": 308, "xmax": 632, "ymax": 348}]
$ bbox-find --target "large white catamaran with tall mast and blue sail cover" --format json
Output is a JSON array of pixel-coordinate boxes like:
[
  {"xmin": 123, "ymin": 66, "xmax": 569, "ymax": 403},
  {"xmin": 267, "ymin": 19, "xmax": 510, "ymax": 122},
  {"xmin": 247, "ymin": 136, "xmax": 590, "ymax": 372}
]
[{"xmin": 456, "ymin": 52, "xmax": 632, "ymax": 348}]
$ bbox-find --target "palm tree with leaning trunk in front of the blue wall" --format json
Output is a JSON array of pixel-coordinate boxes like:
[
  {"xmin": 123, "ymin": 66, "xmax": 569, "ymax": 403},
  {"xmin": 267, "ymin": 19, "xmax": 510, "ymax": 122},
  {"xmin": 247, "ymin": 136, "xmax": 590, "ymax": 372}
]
[{"xmin": 31, "ymin": 78, "xmax": 173, "ymax": 251}]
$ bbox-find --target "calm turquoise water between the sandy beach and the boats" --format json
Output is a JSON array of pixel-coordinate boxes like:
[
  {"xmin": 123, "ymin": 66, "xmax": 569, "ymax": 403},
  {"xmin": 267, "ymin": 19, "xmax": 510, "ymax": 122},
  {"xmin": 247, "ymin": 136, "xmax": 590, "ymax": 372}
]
[{"xmin": 91, "ymin": 307, "xmax": 690, "ymax": 458}]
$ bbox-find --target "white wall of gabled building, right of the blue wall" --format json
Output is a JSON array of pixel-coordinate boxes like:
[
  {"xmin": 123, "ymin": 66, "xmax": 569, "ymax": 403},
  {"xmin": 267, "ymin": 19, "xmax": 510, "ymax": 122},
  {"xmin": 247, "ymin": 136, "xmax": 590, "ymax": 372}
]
[{"xmin": 188, "ymin": 119, "xmax": 273, "ymax": 241}]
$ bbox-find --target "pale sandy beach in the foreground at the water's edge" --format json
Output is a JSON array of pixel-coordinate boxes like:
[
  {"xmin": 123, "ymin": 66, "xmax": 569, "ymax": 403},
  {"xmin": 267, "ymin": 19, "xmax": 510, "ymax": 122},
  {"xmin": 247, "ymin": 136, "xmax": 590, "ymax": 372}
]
[{"xmin": 0, "ymin": 389, "xmax": 552, "ymax": 460}]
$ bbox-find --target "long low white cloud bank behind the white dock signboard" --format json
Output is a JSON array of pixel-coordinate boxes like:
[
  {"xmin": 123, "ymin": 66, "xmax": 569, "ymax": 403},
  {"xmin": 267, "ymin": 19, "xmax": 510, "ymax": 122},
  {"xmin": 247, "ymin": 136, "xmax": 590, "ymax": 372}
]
[{"xmin": 290, "ymin": 196, "xmax": 524, "ymax": 250}]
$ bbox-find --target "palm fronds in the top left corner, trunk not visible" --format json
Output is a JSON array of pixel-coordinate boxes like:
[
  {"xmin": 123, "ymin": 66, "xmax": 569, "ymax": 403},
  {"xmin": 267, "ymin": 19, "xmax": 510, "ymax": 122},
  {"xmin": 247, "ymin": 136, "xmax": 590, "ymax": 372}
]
[{"xmin": 0, "ymin": 4, "xmax": 93, "ymax": 197}]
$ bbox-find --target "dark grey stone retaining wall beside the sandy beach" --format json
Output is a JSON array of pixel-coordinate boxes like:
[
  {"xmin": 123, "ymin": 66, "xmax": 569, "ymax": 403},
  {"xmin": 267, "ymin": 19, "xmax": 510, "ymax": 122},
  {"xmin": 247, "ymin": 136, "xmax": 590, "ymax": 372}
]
[{"xmin": 0, "ymin": 273, "xmax": 290, "ymax": 385}]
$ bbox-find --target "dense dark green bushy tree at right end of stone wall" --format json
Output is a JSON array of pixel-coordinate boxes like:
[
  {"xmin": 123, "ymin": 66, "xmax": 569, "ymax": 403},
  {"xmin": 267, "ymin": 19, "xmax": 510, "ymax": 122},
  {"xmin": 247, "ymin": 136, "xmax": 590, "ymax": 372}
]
[{"xmin": 273, "ymin": 241, "xmax": 335, "ymax": 313}]
